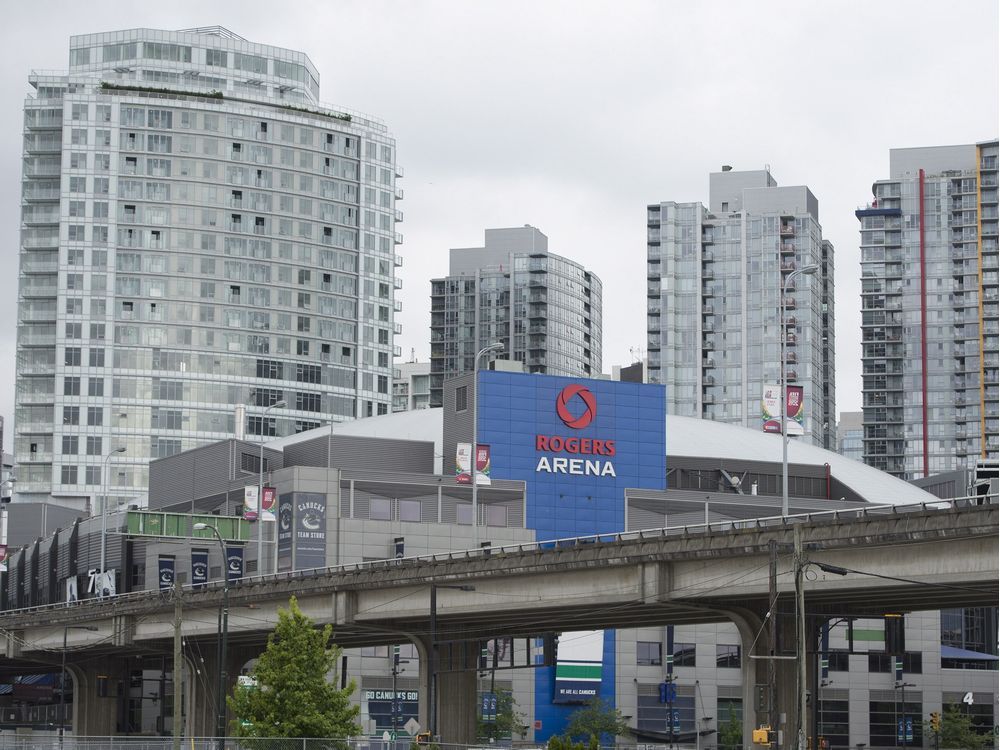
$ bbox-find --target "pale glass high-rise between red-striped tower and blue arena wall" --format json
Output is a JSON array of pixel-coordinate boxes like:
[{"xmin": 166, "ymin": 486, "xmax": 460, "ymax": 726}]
[{"xmin": 646, "ymin": 167, "xmax": 836, "ymax": 449}]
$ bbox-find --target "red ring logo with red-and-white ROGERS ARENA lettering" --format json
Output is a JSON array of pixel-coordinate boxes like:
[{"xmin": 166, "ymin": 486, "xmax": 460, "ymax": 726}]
[{"xmin": 535, "ymin": 383, "xmax": 618, "ymax": 477}]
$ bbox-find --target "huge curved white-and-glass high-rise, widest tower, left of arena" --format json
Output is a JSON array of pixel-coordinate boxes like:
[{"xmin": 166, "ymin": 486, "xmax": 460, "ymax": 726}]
[{"xmin": 14, "ymin": 27, "xmax": 401, "ymax": 507}]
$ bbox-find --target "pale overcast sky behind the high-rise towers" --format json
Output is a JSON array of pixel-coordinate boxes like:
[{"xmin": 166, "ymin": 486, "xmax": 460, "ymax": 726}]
[{"xmin": 0, "ymin": 0, "xmax": 1000, "ymax": 450}]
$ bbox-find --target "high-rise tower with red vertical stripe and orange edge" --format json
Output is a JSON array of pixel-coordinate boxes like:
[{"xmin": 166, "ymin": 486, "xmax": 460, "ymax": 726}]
[{"xmin": 857, "ymin": 140, "xmax": 1000, "ymax": 479}]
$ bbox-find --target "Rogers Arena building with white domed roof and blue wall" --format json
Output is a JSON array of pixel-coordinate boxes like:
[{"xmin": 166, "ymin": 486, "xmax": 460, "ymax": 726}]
[{"xmin": 0, "ymin": 372, "xmax": 997, "ymax": 748}]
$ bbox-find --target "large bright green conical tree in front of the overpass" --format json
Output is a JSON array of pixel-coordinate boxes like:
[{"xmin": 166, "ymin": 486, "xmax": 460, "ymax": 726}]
[{"xmin": 226, "ymin": 596, "xmax": 361, "ymax": 738}]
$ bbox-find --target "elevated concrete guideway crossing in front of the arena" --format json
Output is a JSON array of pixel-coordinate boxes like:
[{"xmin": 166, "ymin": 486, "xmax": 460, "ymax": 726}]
[{"xmin": 0, "ymin": 498, "xmax": 1000, "ymax": 738}]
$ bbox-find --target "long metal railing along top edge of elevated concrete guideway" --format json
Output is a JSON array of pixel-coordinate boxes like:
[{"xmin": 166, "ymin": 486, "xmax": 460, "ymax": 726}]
[{"xmin": 0, "ymin": 494, "xmax": 1000, "ymax": 624}]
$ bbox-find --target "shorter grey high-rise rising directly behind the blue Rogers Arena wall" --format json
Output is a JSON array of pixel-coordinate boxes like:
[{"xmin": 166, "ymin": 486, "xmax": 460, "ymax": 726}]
[{"xmin": 430, "ymin": 225, "xmax": 601, "ymax": 406}]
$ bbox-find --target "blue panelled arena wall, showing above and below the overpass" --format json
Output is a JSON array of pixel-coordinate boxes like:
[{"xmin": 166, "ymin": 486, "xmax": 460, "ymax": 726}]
[{"xmin": 478, "ymin": 371, "xmax": 666, "ymax": 740}]
